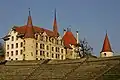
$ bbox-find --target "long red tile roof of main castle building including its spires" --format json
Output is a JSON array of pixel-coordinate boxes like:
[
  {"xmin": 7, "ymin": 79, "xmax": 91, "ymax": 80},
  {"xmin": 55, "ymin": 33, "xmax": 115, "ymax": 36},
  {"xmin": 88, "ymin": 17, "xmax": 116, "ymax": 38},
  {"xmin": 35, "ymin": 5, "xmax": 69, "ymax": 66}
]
[{"xmin": 15, "ymin": 11, "xmax": 57, "ymax": 38}]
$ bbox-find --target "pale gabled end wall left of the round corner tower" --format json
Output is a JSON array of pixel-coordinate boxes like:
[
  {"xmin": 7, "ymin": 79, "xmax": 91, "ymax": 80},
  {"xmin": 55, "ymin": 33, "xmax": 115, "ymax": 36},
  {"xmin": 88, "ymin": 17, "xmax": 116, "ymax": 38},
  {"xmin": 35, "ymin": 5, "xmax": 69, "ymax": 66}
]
[{"xmin": 5, "ymin": 30, "xmax": 23, "ymax": 60}]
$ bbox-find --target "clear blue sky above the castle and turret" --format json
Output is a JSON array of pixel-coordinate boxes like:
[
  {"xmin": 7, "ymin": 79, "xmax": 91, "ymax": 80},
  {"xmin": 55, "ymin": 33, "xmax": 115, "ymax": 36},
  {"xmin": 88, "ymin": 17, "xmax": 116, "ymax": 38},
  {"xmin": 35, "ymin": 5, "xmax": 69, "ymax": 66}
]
[{"xmin": 0, "ymin": 0, "xmax": 120, "ymax": 56}]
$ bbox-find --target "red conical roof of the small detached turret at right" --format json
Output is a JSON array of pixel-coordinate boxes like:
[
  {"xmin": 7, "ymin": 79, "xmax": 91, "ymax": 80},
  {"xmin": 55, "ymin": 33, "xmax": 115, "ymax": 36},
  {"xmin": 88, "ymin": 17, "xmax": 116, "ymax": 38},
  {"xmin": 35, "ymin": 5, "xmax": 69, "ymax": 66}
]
[{"xmin": 101, "ymin": 33, "xmax": 112, "ymax": 52}]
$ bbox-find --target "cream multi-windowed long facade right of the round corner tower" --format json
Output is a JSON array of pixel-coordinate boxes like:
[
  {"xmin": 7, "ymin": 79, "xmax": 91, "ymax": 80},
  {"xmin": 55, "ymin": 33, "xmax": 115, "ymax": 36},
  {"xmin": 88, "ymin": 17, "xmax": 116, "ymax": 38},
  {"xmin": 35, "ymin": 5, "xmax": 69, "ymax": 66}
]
[{"xmin": 36, "ymin": 32, "xmax": 65, "ymax": 60}]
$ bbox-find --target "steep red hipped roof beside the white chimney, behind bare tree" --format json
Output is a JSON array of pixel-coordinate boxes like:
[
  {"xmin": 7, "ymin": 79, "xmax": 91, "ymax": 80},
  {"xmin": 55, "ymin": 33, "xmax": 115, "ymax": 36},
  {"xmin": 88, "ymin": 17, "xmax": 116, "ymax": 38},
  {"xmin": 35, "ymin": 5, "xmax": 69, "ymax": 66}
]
[{"xmin": 62, "ymin": 31, "xmax": 77, "ymax": 48}]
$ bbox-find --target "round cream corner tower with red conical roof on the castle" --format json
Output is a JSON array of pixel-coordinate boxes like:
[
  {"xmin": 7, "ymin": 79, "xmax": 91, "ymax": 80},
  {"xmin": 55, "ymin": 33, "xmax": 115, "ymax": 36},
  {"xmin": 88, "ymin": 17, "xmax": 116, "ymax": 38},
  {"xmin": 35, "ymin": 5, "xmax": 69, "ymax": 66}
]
[{"xmin": 23, "ymin": 8, "xmax": 36, "ymax": 60}]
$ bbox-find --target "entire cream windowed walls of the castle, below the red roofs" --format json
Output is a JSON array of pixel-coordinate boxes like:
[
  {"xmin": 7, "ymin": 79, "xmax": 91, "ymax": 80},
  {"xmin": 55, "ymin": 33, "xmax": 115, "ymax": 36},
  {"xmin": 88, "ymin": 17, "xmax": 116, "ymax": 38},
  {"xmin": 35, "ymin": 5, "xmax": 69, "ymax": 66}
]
[{"xmin": 5, "ymin": 30, "xmax": 79, "ymax": 60}]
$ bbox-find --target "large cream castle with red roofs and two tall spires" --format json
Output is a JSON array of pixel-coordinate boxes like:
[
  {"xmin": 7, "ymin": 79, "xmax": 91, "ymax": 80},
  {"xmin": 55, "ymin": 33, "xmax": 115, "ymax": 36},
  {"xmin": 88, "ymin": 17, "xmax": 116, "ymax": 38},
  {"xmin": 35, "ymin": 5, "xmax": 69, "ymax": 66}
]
[{"xmin": 3, "ymin": 10, "xmax": 80, "ymax": 61}]
